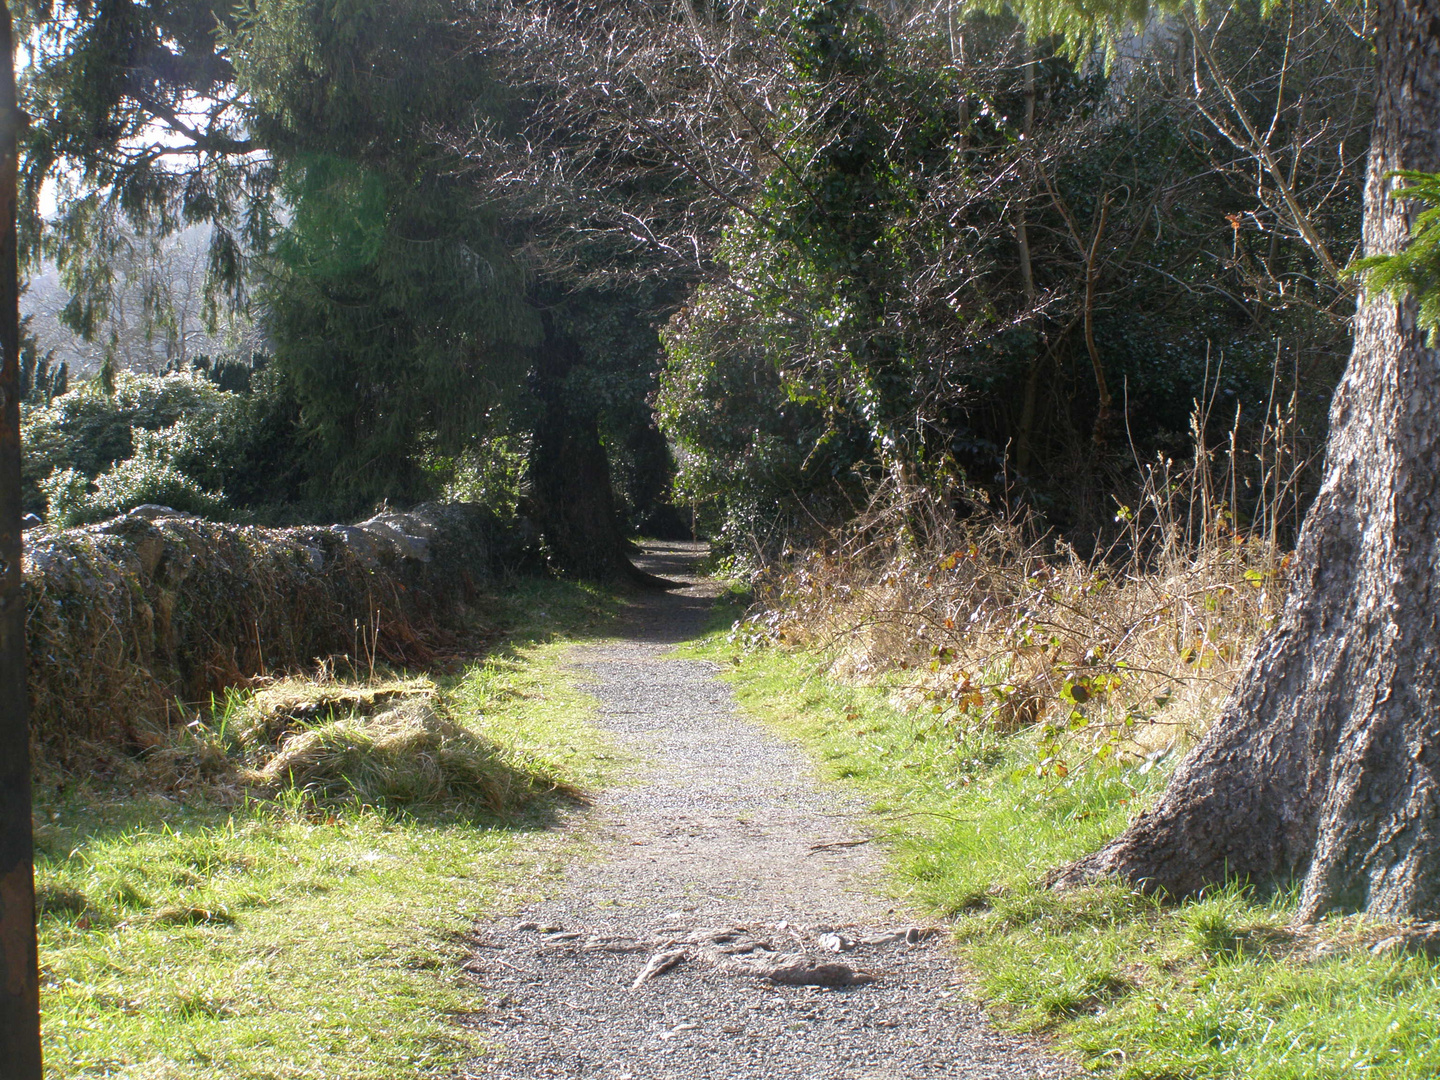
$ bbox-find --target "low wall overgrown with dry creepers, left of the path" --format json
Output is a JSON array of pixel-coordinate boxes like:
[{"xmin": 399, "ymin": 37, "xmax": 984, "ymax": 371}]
[{"xmin": 24, "ymin": 507, "xmax": 504, "ymax": 768}]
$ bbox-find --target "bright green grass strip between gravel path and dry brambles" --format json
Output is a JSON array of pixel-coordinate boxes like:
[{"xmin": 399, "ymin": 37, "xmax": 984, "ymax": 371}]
[{"xmin": 682, "ymin": 616, "xmax": 1440, "ymax": 1080}]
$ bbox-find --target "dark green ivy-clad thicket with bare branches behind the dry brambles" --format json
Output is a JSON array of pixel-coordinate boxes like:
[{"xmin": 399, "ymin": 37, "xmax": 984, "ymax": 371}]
[{"xmin": 657, "ymin": 0, "xmax": 1369, "ymax": 557}]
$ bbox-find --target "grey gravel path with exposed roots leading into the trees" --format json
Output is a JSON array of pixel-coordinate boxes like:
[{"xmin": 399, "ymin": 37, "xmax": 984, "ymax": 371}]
[{"xmin": 467, "ymin": 544, "xmax": 1074, "ymax": 1080}]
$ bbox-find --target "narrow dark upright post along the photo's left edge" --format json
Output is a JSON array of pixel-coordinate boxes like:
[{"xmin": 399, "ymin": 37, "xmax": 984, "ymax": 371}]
[{"xmin": 0, "ymin": 0, "xmax": 40, "ymax": 1080}]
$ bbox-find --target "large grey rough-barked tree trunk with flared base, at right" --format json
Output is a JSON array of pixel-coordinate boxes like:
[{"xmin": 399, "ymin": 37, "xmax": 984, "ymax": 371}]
[{"xmin": 1058, "ymin": 0, "xmax": 1440, "ymax": 920}]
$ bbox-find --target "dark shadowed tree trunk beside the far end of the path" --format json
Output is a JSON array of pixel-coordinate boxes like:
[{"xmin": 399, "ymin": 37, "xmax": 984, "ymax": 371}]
[{"xmin": 530, "ymin": 314, "xmax": 668, "ymax": 585}]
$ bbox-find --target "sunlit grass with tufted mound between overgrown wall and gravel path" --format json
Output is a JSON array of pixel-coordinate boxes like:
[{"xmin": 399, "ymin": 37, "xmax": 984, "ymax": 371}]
[{"xmin": 37, "ymin": 583, "xmax": 615, "ymax": 1080}]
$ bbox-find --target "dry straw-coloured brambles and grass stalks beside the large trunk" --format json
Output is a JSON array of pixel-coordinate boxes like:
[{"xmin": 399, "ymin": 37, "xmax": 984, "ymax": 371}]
[{"xmin": 737, "ymin": 406, "xmax": 1299, "ymax": 775}]
